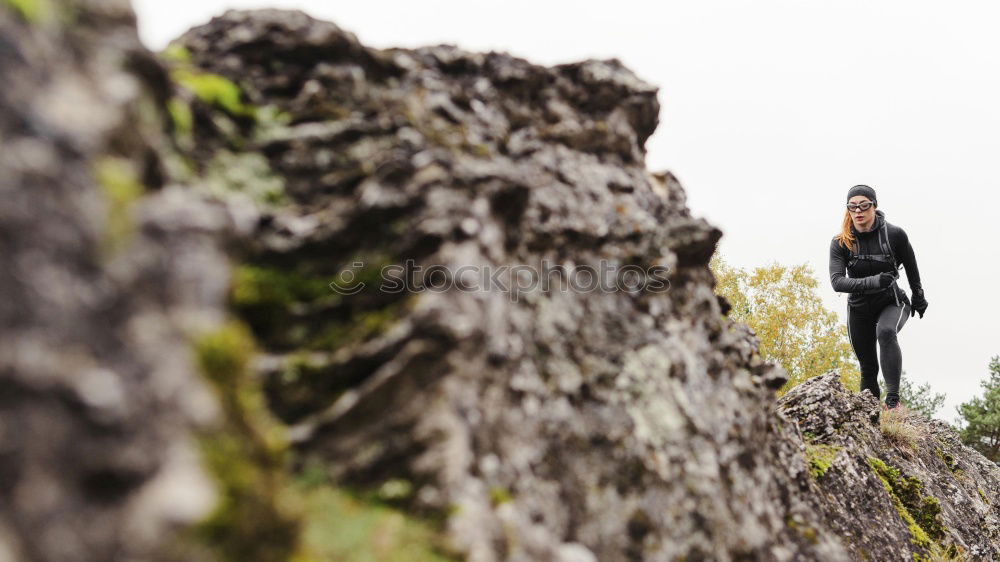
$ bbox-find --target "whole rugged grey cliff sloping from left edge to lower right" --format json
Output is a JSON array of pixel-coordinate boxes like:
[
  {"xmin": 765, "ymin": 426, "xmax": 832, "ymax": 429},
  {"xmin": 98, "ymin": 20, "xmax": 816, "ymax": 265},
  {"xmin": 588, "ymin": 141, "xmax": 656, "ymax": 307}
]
[{"xmin": 0, "ymin": 1, "xmax": 1000, "ymax": 561}]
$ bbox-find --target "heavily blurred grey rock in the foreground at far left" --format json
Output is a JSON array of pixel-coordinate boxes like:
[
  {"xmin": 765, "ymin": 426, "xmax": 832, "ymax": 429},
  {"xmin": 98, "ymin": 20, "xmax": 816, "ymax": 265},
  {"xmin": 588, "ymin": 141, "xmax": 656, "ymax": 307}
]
[{"xmin": 0, "ymin": 2, "xmax": 228, "ymax": 561}]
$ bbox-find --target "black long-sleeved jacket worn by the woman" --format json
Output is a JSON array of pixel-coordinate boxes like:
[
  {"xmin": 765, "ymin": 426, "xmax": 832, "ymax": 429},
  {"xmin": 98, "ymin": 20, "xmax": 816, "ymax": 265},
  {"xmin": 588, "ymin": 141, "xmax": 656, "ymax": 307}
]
[{"xmin": 830, "ymin": 209, "xmax": 924, "ymax": 306}]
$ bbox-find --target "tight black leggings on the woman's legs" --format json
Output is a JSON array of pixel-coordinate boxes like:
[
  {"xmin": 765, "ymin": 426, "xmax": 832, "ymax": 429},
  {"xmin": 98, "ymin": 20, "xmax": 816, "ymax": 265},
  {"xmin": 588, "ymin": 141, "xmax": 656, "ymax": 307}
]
[{"xmin": 847, "ymin": 302, "xmax": 910, "ymax": 407}]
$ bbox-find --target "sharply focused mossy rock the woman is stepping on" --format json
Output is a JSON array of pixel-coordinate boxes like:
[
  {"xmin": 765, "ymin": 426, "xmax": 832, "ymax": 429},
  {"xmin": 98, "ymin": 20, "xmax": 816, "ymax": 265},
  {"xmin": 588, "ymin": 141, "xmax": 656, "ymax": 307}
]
[{"xmin": 778, "ymin": 372, "xmax": 1000, "ymax": 560}]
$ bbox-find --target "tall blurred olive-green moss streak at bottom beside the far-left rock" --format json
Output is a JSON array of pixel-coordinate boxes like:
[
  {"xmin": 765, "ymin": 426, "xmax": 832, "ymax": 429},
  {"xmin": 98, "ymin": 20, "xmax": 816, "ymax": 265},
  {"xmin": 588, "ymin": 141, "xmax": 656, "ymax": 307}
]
[{"xmin": 194, "ymin": 322, "xmax": 300, "ymax": 562}]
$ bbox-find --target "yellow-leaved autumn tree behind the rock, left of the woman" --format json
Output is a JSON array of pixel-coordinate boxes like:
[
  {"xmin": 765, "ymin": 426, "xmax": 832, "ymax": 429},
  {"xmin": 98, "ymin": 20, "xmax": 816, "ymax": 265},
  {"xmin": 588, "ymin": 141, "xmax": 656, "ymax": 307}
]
[{"xmin": 709, "ymin": 253, "xmax": 860, "ymax": 396}]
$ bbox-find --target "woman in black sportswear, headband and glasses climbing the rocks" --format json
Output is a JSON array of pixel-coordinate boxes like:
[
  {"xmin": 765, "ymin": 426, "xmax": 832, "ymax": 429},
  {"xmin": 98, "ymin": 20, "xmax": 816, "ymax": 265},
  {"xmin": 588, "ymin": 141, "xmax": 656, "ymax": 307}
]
[{"xmin": 830, "ymin": 185, "xmax": 927, "ymax": 410}]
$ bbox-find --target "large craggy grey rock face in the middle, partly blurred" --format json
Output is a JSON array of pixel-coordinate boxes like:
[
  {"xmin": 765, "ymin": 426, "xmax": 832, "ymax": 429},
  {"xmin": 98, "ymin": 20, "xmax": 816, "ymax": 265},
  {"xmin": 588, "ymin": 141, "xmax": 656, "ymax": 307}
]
[{"xmin": 175, "ymin": 10, "xmax": 847, "ymax": 561}]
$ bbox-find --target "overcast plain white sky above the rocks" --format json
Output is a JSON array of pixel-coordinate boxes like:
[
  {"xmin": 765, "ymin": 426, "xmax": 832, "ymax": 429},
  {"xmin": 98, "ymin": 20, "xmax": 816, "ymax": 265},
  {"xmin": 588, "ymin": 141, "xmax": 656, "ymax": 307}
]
[{"xmin": 133, "ymin": 0, "xmax": 1000, "ymax": 421}]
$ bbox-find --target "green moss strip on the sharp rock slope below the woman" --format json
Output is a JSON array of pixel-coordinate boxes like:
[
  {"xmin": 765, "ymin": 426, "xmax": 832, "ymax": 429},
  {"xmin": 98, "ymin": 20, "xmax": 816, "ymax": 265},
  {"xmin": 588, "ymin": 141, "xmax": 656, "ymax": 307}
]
[{"xmin": 868, "ymin": 457, "xmax": 945, "ymax": 549}]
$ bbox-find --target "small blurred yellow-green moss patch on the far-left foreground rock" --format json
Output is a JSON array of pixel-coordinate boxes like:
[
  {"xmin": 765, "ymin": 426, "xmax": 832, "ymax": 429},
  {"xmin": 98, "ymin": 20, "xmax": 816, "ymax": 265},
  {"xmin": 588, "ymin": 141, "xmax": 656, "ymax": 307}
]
[{"xmin": 92, "ymin": 156, "xmax": 144, "ymax": 249}]
